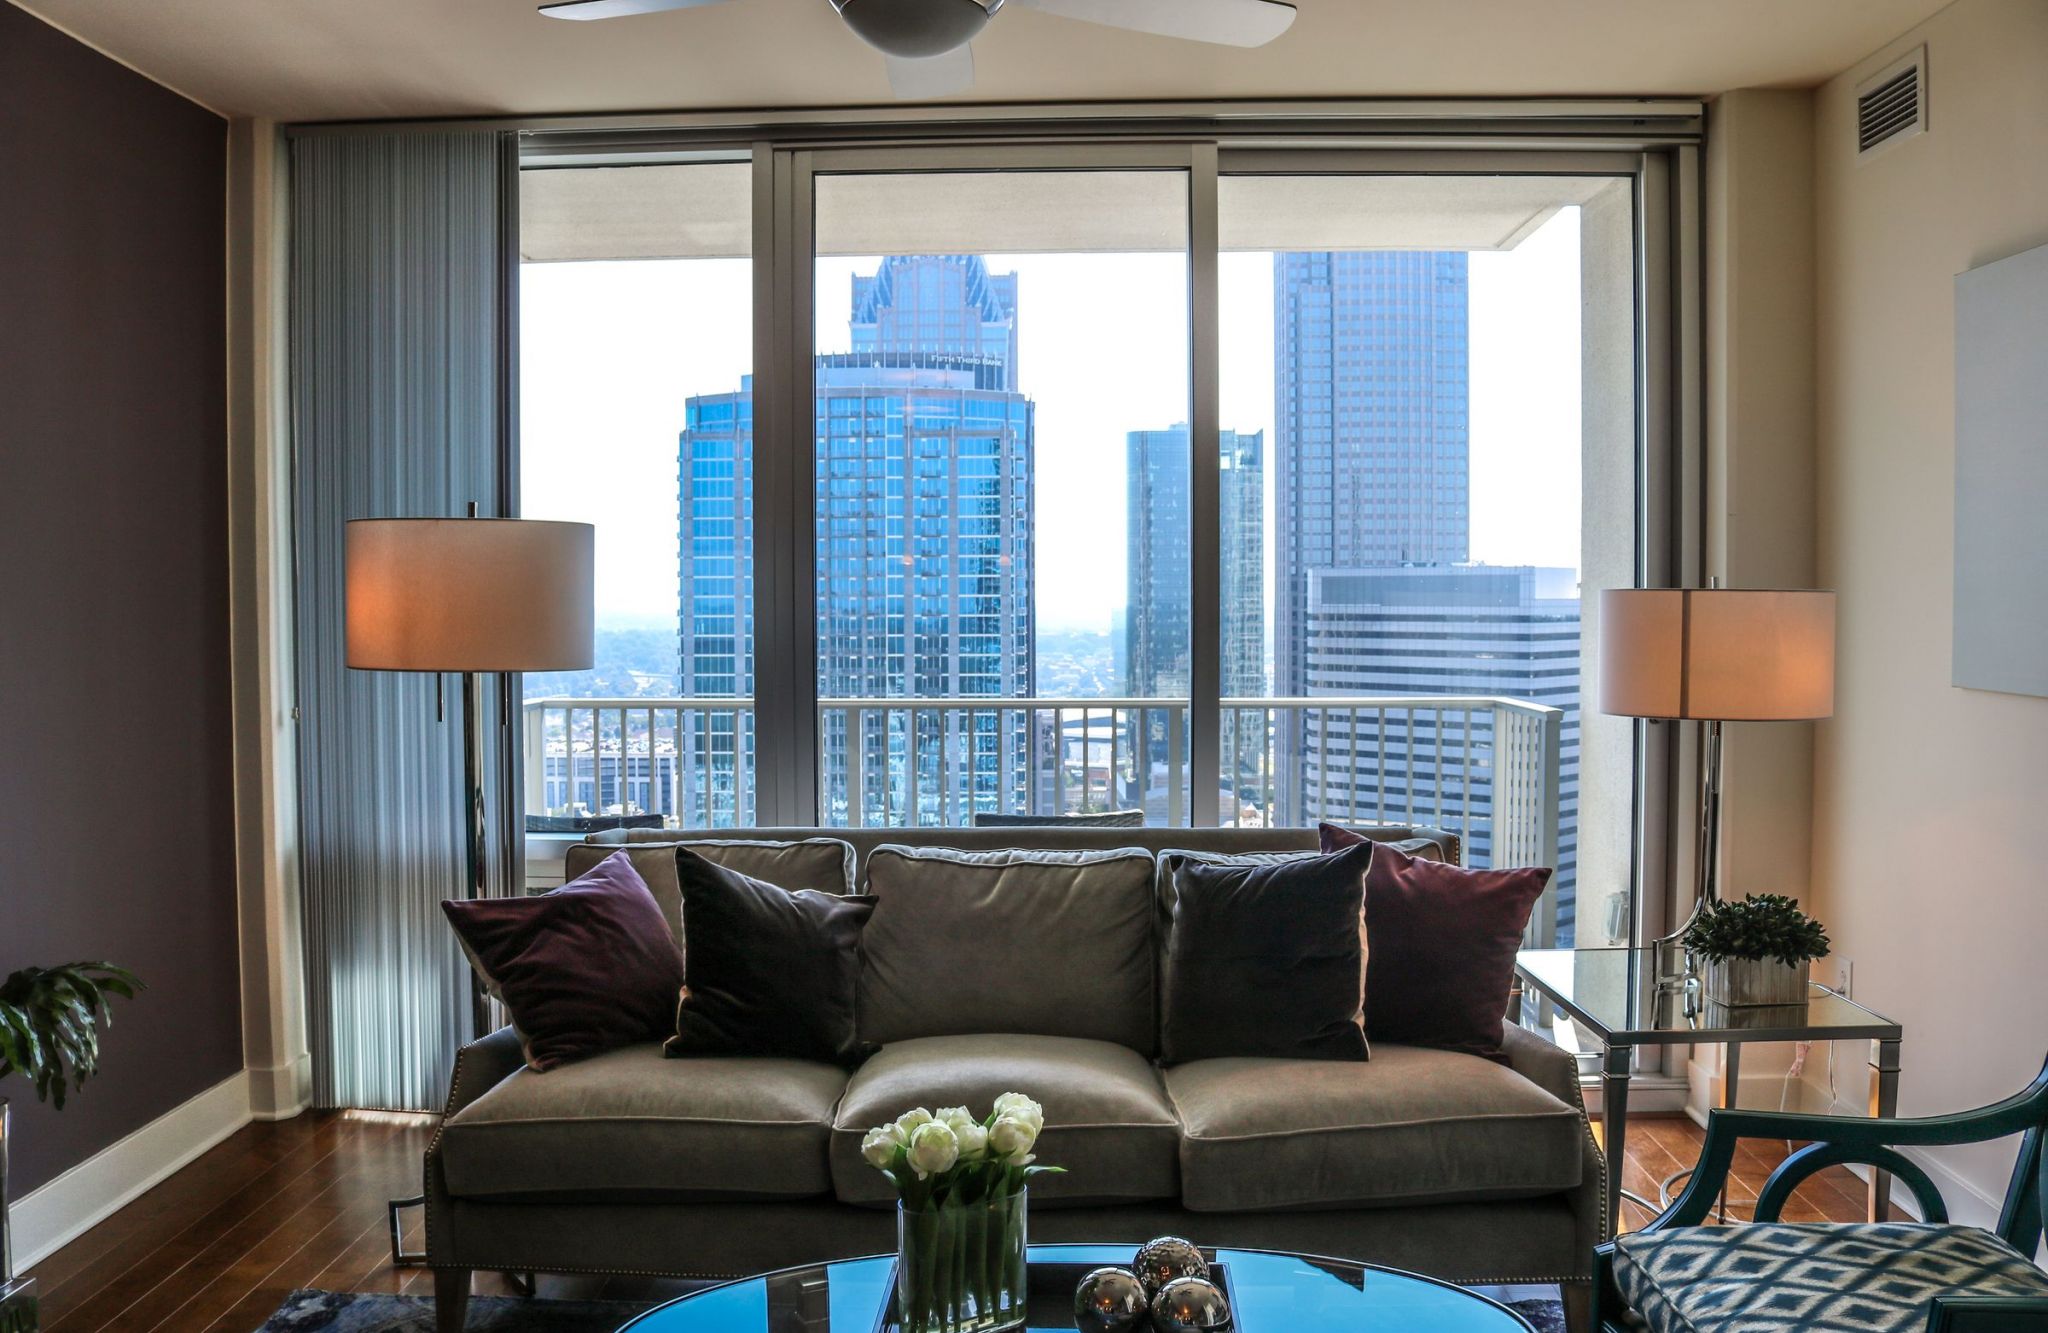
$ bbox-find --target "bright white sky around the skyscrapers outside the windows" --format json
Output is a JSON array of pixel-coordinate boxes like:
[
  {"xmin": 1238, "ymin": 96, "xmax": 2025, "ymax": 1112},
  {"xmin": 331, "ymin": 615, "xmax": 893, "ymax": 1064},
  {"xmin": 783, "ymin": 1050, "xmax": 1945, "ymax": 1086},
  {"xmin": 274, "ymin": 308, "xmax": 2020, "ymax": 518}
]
[{"xmin": 520, "ymin": 209, "xmax": 1579, "ymax": 635}]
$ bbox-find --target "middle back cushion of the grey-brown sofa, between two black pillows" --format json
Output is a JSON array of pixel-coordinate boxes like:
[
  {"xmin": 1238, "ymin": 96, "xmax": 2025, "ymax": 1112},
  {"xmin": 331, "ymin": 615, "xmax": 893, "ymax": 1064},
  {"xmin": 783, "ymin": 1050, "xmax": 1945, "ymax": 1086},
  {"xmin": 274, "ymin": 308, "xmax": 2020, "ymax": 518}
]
[{"xmin": 860, "ymin": 846, "xmax": 1157, "ymax": 1055}]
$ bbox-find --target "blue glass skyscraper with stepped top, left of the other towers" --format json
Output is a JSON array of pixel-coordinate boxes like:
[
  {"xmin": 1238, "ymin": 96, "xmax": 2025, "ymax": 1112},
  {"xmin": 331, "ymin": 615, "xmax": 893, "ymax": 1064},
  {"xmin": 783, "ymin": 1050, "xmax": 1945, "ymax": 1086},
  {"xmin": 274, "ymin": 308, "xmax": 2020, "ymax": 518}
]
[{"xmin": 680, "ymin": 256, "xmax": 1036, "ymax": 823}]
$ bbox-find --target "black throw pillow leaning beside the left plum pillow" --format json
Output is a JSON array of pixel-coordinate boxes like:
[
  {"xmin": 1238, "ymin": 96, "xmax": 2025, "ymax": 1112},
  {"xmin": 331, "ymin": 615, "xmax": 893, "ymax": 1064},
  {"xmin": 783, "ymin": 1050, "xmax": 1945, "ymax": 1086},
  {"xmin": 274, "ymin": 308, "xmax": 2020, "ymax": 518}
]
[{"xmin": 666, "ymin": 848, "xmax": 874, "ymax": 1065}]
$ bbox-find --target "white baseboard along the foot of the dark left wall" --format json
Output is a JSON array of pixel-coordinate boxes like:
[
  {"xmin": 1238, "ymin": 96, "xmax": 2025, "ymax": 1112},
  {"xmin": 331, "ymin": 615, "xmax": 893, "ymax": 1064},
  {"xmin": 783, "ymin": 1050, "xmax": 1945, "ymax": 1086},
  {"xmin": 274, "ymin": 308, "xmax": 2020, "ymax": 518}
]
[{"xmin": 10, "ymin": 1071, "xmax": 250, "ymax": 1272}]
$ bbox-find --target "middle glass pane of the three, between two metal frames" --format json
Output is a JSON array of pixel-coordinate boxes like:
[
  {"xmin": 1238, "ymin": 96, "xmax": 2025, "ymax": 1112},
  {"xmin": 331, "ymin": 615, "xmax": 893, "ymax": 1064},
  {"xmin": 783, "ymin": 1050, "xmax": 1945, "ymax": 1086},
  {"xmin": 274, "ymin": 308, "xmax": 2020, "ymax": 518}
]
[{"xmin": 798, "ymin": 172, "xmax": 1188, "ymax": 825}]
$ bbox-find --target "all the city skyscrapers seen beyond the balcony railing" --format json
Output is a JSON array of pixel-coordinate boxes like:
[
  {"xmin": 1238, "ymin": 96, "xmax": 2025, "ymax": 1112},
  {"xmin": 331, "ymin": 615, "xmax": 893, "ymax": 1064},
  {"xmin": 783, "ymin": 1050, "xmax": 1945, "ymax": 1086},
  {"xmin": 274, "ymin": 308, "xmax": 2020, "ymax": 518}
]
[{"xmin": 524, "ymin": 232, "xmax": 1577, "ymax": 895}]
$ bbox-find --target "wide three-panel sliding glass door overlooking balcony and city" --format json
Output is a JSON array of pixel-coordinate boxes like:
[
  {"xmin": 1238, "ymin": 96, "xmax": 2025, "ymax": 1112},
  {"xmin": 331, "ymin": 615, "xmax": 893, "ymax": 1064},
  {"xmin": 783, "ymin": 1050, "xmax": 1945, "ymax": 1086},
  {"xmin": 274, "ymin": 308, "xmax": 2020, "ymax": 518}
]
[{"xmin": 507, "ymin": 135, "xmax": 1694, "ymax": 946}]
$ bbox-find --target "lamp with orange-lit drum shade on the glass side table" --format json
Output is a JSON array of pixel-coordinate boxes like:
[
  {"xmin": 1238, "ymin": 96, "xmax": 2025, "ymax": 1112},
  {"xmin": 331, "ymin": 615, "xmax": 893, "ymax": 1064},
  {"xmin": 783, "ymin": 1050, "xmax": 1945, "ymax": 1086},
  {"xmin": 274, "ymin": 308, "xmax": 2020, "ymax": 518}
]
[{"xmin": 1599, "ymin": 588, "xmax": 1835, "ymax": 985}]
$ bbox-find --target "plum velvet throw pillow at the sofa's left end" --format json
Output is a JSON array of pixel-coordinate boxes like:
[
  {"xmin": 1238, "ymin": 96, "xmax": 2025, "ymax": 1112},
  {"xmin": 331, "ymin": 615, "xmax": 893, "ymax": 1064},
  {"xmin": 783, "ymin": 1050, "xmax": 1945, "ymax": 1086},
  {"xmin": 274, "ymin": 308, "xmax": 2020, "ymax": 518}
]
[{"xmin": 440, "ymin": 852, "xmax": 682, "ymax": 1071}]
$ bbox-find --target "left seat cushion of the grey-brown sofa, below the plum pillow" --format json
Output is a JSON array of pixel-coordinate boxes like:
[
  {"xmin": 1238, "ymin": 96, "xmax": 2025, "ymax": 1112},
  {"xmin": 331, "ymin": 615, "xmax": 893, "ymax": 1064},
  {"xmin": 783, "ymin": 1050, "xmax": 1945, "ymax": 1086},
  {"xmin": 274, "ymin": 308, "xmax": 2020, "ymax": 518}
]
[{"xmin": 440, "ymin": 1042, "xmax": 846, "ymax": 1202}]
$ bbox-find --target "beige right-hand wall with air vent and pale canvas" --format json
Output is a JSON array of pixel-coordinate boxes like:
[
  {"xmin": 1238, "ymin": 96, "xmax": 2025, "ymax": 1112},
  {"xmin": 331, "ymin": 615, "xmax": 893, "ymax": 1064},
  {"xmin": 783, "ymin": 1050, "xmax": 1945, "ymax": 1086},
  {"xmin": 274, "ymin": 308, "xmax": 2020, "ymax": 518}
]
[{"xmin": 1812, "ymin": 0, "xmax": 2048, "ymax": 1206}]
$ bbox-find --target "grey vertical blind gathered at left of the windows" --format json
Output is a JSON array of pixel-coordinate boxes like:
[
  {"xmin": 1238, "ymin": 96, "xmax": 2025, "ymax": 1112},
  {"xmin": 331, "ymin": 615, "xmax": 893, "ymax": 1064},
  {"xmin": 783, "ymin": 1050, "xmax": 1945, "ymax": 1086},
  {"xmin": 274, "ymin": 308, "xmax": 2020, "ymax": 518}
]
[{"xmin": 291, "ymin": 129, "xmax": 518, "ymax": 1110}]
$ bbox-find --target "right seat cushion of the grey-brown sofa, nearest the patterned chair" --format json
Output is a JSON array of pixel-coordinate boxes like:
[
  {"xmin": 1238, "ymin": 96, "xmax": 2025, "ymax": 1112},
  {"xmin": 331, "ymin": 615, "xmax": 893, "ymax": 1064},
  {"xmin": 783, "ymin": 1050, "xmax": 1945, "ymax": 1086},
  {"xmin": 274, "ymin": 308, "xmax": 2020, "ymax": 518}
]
[{"xmin": 1165, "ymin": 1042, "xmax": 1587, "ymax": 1212}]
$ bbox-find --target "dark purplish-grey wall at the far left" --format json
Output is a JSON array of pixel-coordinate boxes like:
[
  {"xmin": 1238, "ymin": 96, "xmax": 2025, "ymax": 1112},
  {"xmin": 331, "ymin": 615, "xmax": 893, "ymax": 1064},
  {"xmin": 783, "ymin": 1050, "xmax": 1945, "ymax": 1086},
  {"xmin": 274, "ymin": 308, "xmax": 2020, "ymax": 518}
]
[{"xmin": 0, "ymin": 4, "xmax": 242, "ymax": 1194}]
